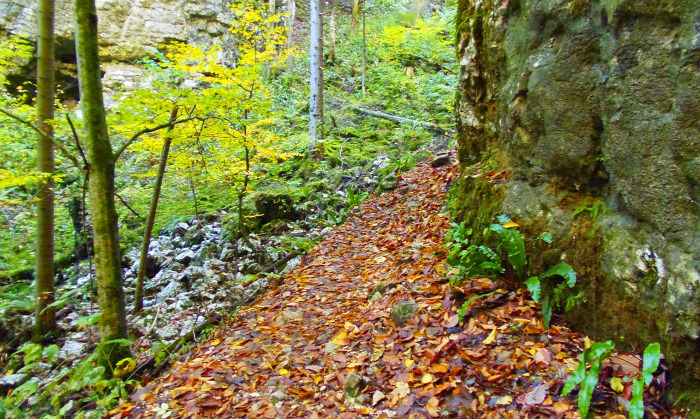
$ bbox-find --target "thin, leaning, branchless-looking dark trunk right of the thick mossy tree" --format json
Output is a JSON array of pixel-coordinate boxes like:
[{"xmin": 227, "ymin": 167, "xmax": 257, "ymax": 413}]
[{"xmin": 134, "ymin": 106, "xmax": 178, "ymax": 314}]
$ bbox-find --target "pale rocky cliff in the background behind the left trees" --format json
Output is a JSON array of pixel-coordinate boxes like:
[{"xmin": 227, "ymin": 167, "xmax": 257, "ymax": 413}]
[{"xmin": 0, "ymin": 0, "xmax": 236, "ymax": 99}]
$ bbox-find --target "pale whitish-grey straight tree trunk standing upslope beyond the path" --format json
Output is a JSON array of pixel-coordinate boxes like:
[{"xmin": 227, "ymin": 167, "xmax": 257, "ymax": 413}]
[{"xmin": 309, "ymin": 0, "xmax": 323, "ymax": 155}]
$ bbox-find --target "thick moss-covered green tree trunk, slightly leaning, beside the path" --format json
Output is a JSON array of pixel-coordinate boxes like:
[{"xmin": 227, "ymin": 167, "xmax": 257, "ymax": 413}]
[{"xmin": 75, "ymin": 0, "xmax": 131, "ymax": 377}]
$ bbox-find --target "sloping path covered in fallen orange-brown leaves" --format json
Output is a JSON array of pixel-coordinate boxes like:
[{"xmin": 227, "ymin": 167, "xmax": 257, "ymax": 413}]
[{"xmin": 110, "ymin": 156, "xmax": 669, "ymax": 418}]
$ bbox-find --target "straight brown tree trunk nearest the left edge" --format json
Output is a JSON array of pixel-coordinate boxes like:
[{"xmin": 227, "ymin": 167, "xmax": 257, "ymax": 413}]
[{"xmin": 34, "ymin": 0, "xmax": 56, "ymax": 340}]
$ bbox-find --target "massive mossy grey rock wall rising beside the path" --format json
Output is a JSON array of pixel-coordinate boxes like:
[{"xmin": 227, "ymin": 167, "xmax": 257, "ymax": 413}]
[{"xmin": 455, "ymin": 0, "xmax": 700, "ymax": 403}]
